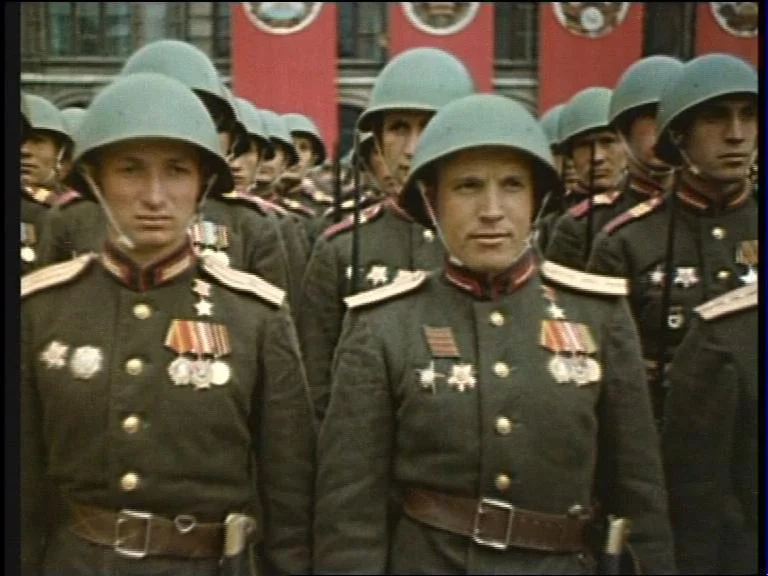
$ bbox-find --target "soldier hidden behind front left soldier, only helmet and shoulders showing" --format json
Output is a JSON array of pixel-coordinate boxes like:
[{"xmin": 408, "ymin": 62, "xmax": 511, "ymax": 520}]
[{"xmin": 34, "ymin": 40, "xmax": 289, "ymax": 300}]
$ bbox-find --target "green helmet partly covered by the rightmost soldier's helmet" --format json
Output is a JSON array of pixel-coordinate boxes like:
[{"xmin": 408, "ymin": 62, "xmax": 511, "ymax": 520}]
[{"xmin": 608, "ymin": 56, "xmax": 683, "ymax": 131}]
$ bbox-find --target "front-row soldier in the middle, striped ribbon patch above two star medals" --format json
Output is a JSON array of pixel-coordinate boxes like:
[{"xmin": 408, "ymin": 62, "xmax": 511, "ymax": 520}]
[{"xmin": 314, "ymin": 94, "xmax": 674, "ymax": 574}]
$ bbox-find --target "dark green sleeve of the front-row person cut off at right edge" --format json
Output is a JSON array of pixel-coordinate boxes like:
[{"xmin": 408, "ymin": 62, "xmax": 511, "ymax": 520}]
[{"xmin": 663, "ymin": 317, "xmax": 739, "ymax": 574}]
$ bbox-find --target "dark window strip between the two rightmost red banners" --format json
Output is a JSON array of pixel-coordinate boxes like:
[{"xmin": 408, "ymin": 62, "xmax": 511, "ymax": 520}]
[{"xmin": 643, "ymin": 2, "xmax": 698, "ymax": 60}]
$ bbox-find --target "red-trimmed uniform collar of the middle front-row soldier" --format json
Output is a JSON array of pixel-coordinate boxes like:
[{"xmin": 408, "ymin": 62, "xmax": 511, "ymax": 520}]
[{"xmin": 443, "ymin": 247, "xmax": 537, "ymax": 300}]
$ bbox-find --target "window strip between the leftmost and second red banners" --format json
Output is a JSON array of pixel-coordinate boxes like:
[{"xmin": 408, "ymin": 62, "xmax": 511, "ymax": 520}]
[{"xmin": 336, "ymin": 2, "xmax": 388, "ymax": 62}]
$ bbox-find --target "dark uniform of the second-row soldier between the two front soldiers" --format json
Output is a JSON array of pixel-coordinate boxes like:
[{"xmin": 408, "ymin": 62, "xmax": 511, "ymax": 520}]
[{"xmin": 298, "ymin": 202, "xmax": 444, "ymax": 419}]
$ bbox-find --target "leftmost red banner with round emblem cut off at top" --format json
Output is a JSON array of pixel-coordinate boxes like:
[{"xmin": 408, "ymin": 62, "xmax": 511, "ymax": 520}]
[{"xmin": 231, "ymin": 2, "xmax": 338, "ymax": 155}]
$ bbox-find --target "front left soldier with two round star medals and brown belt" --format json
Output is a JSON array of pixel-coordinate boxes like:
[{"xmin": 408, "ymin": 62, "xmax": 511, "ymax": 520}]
[{"xmin": 21, "ymin": 73, "xmax": 314, "ymax": 576}]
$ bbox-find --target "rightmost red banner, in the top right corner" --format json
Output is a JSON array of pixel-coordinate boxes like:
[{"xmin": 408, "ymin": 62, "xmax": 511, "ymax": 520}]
[{"xmin": 696, "ymin": 2, "xmax": 760, "ymax": 67}]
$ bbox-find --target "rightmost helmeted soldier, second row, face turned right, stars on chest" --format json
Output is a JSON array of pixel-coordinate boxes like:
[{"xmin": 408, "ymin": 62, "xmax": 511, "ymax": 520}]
[{"xmin": 588, "ymin": 54, "xmax": 758, "ymax": 422}]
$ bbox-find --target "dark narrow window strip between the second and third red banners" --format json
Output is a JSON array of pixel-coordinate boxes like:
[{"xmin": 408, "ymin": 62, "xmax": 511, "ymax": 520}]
[{"xmin": 494, "ymin": 2, "xmax": 536, "ymax": 65}]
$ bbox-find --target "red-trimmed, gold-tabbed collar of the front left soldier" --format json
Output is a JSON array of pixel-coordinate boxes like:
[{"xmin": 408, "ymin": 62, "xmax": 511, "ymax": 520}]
[{"xmin": 99, "ymin": 241, "xmax": 197, "ymax": 292}]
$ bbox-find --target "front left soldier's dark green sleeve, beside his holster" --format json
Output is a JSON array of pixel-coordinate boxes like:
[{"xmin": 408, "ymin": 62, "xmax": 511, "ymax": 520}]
[{"xmin": 256, "ymin": 310, "xmax": 315, "ymax": 574}]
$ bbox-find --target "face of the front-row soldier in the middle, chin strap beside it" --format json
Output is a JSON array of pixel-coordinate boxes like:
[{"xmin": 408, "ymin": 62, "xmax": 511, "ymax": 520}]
[{"xmin": 436, "ymin": 147, "xmax": 534, "ymax": 274}]
